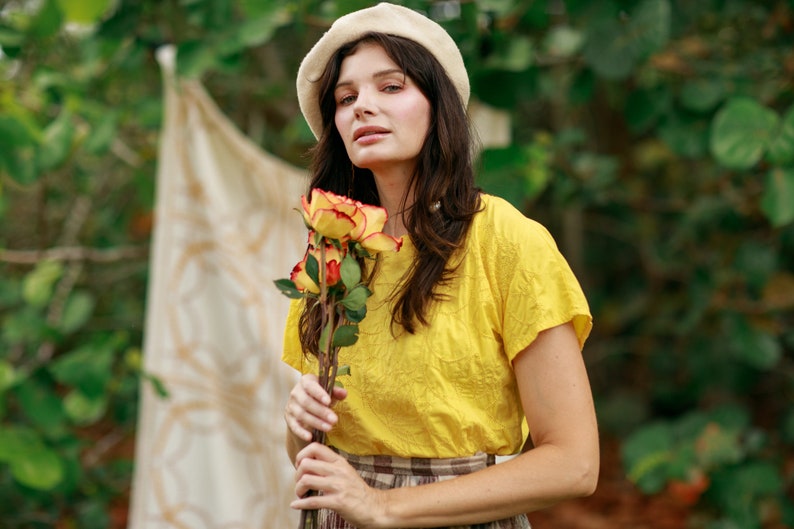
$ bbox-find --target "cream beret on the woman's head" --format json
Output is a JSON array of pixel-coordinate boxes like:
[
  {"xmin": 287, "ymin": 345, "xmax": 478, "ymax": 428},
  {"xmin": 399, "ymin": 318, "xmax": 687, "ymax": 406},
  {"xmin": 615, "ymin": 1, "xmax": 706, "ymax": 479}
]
[{"xmin": 296, "ymin": 2, "xmax": 469, "ymax": 138}]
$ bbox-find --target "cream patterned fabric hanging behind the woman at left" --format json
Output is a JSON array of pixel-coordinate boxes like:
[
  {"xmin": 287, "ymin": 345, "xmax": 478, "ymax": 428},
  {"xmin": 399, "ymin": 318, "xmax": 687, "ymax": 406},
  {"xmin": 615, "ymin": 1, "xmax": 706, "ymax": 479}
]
[{"xmin": 129, "ymin": 49, "xmax": 306, "ymax": 529}]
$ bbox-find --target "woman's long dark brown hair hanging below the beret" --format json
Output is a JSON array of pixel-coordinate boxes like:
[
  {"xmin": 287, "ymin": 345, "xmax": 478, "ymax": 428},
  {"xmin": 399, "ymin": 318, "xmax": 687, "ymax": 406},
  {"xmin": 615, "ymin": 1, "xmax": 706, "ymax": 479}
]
[{"xmin": 300, "ymin": 33, "xmax": 480, "ymax": 354}]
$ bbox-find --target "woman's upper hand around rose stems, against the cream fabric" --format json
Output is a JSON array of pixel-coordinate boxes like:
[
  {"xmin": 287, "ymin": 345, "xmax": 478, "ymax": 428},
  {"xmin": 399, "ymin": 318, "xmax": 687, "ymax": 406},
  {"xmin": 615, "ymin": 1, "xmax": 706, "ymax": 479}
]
[{"xmin": 284, "ymin": 375, "xmax": 347, "ymax": 448}]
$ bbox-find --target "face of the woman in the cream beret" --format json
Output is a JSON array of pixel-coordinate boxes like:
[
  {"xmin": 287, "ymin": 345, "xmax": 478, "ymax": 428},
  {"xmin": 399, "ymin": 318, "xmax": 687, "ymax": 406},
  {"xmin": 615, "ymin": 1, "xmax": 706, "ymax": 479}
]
[{"xmin": 334, "ymin": 44, "xmax": 430, "ymax": 176}]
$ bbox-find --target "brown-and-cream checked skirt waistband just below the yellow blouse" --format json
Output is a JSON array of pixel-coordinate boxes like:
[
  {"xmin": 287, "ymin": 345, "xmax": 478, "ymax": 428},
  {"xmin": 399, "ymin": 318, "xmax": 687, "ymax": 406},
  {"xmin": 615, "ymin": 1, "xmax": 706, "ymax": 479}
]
[{"xmin": 334, "ymin": 448, "xmax": 496, "ymax": 476}]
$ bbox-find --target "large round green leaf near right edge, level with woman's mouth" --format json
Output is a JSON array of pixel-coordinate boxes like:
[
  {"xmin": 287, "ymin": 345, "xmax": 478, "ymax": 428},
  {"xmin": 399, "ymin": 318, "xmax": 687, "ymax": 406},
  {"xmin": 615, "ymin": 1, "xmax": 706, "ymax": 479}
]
[{"xmin": 710, "ymin": 97, "xmax": 780, "ymax": 170}]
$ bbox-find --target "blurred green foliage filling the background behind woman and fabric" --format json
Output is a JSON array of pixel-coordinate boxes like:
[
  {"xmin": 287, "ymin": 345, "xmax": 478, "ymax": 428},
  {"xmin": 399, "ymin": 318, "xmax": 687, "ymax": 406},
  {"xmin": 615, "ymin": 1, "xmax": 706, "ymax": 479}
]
[{"xmin": 0, "ymin": 0, "xmax": 794, "ymax": 529}]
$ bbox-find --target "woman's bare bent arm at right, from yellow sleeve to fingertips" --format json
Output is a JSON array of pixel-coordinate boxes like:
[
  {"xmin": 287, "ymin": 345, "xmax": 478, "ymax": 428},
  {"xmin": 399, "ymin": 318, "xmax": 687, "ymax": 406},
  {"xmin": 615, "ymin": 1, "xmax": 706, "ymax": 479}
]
[{"xmin": 292, "ymin": 324, "xmax": 599, "ymax": 528}]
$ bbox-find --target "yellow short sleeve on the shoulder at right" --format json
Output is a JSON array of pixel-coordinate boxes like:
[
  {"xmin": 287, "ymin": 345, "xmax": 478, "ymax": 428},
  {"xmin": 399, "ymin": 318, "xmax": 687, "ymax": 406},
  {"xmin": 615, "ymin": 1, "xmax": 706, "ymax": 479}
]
[{"xmin": 486, "ymin": 196, "xmax": 593, "ymax": 362}]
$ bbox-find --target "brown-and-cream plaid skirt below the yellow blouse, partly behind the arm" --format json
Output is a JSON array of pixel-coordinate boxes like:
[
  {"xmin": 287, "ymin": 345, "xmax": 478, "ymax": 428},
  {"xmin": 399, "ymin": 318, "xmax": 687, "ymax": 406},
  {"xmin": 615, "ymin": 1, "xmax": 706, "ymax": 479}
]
[{"xmin": 312, "ymin": 449, "xmax": 530, "ymax": 529}]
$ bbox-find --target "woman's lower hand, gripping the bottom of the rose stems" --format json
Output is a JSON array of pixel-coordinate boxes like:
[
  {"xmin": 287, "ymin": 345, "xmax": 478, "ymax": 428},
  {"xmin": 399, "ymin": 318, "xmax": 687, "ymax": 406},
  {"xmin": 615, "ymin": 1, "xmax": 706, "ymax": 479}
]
[{"xmin": 290, "ymin": 443, "xmax": 385, "ymax": 529}]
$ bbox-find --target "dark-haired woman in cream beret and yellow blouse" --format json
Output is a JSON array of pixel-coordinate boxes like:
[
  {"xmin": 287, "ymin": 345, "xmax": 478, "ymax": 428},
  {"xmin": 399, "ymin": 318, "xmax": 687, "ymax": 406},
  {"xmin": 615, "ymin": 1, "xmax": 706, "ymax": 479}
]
[{"xmin": 284, "ymin": 4, "xmax": 599, "ymax": 529}]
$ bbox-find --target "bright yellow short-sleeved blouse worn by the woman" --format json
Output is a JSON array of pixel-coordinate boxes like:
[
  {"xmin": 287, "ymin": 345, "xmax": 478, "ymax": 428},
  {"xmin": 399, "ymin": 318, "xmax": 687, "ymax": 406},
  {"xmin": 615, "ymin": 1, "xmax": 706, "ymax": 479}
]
[{"xmin": 283, "ymin": 195, "xmax": 592, "ymax": 458}]
